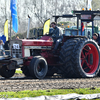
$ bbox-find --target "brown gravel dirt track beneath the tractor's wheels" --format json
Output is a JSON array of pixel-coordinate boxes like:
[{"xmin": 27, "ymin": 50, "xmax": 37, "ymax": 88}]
[{"xmin": 0, "ymin": 74, "xmax": 100, "ymax": 92}]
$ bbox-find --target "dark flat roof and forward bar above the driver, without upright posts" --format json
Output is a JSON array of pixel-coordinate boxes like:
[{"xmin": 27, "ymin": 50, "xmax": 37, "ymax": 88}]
[{"xmin": 53, "ymin": 10, "xmax": 100, "ymax": 22}]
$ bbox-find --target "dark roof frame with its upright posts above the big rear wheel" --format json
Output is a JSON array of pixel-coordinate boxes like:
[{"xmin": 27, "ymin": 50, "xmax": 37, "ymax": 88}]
[{"xmin": 53, "ymin": 10, "xmax": 100, "ymax": 35}]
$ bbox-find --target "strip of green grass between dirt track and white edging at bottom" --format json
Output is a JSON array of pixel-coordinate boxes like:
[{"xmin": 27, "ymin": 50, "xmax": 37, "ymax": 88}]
[{"xmin": 0, "ymin": 88, "xmax": 100, "ymax": 100}]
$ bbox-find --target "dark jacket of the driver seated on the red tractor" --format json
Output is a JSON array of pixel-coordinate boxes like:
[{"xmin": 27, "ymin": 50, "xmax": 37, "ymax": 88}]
[{"xmin": 49, "ymin": 27, "xmax": 63, "ymax": 41}]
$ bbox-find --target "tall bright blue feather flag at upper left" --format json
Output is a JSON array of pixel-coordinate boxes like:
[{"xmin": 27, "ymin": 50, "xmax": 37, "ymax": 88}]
[{"xmin": 10, "ymin": 0, "xmax": 18, "ymax": 33}]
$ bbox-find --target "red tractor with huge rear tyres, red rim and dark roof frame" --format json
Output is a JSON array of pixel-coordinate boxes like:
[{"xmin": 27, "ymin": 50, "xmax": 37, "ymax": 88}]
[{"xmin": 0, "ymin": 11, "xmax": 100, "ymax": 79}]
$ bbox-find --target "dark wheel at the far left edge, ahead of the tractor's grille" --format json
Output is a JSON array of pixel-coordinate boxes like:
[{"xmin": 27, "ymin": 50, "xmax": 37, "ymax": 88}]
[{"xmin": 0, "ymin": 65, "xmax": 15, "ymax": 78}]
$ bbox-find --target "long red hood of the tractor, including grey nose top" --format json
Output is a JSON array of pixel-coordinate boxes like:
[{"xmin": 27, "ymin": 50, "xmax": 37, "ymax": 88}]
[{"xmin": 10, "ymin": 36, "xmax": 53, "ymax": 46}]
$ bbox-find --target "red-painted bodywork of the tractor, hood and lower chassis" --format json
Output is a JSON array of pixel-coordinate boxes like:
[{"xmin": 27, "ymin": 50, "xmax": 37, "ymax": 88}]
[{"xmin": 22, "ymin": 36, "xmax": 58, "ymax": 65}]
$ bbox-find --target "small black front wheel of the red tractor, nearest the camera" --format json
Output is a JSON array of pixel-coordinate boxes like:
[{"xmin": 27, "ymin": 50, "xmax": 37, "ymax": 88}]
[{"xmin": 29, "ymin": 56, "xmax": 48, "ymax": 79}]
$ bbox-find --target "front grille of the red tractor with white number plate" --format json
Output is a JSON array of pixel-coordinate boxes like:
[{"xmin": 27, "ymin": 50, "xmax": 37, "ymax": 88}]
[{"xmin": 10, "ymin": 40, "xmax": 22, "ymax": 58}]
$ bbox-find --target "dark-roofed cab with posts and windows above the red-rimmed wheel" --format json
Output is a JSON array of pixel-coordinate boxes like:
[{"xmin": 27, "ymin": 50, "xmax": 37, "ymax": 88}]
[{"xmin": 73, "ymin": 10, "xmax": 100, "ymax": 38}]
